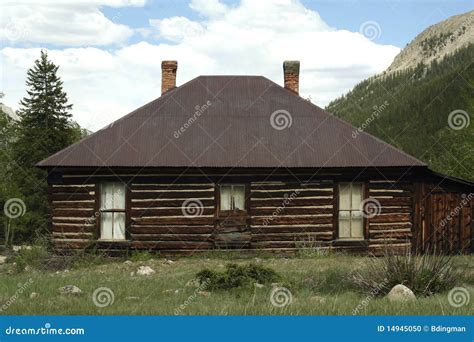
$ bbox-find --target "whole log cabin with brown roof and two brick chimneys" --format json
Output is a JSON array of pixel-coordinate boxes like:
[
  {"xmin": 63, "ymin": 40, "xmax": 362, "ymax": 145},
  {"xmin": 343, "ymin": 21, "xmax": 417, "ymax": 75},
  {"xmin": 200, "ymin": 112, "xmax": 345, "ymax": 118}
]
[{"xmin": 37, "ymin": 61, "xmax": 474, "ymax": 255}]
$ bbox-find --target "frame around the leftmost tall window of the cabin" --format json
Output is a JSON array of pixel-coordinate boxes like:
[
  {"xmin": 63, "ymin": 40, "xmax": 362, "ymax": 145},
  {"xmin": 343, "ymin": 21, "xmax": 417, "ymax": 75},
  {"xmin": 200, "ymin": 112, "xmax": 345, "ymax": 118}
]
[{"xmin": 96, "ymin": 180, "xmax": 130, "ymax": 243}]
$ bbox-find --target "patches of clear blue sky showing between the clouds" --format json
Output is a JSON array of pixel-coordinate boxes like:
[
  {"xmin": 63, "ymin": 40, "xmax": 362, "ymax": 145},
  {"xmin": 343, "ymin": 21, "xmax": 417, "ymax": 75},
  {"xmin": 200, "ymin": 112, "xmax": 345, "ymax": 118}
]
[{"xmin": 103, "ymin": 0, "xmax": 474, "ymax": 48}]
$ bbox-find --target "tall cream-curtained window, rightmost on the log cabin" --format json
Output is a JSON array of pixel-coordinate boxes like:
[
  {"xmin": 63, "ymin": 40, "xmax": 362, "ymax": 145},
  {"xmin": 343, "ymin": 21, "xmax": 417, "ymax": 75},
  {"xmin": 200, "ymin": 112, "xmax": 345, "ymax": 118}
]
[{"xmin": 339, "ymin": 183, "xmax": 364, "ymax": 239}]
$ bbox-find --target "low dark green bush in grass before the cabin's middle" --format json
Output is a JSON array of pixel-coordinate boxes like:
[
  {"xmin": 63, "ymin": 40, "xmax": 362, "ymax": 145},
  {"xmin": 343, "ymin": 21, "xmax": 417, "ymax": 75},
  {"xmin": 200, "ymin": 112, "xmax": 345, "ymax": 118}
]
[{"xmin": 196, "ymin": 264, "xmax": 281, "ymax": 290}]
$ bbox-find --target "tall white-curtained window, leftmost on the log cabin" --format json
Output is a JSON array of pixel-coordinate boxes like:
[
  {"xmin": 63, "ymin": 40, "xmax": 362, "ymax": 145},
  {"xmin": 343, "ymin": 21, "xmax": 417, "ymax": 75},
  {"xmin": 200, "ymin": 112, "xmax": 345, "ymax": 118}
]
[{"xmin": 100, "ymin": 183, "xmax": 125, "ymax": 240}]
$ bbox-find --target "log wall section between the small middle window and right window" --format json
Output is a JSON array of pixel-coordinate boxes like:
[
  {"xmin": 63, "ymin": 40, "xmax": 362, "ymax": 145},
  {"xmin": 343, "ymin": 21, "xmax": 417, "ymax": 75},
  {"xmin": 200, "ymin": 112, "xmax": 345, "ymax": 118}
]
[{"xmin": 250, "ymin": 181, "xmax": 334, "ymax": 250}]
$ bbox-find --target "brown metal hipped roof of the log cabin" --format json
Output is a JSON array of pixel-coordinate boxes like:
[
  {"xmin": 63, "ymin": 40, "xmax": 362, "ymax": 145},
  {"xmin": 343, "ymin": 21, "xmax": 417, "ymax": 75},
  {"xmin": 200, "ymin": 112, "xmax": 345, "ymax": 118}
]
[{"xmin": 38, "ymin": 76, "xmax": 425, "ymax": 167}]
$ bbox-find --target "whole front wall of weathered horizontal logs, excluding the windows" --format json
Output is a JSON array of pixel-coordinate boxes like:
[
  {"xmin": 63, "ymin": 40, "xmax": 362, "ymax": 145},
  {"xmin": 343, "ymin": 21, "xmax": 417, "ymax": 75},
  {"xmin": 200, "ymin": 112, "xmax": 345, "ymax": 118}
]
[{"xmin": 50, "ymin": 171, "xmax": 430, "ymax": 254}]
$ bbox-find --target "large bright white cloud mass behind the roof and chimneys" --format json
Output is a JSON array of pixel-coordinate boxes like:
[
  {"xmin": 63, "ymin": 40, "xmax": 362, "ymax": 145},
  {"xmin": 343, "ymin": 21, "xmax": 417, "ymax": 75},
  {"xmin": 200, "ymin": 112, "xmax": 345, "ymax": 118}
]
[{"xmin": 1, "ymin": 0, "xmax": 400, "ymax": 129}]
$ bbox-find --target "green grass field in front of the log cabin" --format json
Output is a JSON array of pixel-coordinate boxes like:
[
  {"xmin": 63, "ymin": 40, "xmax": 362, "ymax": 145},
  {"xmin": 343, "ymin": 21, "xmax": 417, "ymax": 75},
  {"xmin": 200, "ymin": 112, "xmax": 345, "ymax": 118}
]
[{"xmin": 0, "ymin": 254, "xmax": 474, "ymax": 315}]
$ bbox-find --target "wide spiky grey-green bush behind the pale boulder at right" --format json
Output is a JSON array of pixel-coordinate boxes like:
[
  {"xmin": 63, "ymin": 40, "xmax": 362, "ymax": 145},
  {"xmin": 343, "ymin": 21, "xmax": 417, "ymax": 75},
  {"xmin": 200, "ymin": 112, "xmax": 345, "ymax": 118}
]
[{"xmin": 353, "ymin": 250, "xmax": 455, "ymax": 296}]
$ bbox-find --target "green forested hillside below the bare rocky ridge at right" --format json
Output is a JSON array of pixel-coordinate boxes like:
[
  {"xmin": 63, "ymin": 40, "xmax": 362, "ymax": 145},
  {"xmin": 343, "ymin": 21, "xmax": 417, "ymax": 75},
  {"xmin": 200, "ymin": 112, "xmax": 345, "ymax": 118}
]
[{"xmin": 326, "ymin": 44, "xmax": 474, "ymax": 181}]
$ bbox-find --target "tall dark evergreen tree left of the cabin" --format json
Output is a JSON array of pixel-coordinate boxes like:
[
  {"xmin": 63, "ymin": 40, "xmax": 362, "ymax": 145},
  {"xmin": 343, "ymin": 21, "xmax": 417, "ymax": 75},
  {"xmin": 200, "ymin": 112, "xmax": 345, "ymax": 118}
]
[{"xmin": 13, "ymin": 51, "xmax": 80, "ymax": 239}]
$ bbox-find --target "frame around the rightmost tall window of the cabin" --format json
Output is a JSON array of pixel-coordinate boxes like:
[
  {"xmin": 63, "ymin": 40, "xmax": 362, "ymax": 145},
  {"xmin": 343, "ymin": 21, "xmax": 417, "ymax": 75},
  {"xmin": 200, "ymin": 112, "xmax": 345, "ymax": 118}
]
[{"xmin": 334, "ymin": 181, "xmax": 369, "ymax": 243}]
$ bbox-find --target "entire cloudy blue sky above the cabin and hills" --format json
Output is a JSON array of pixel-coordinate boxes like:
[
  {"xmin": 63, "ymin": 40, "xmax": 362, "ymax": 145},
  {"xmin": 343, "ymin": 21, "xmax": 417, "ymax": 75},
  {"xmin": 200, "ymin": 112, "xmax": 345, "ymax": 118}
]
[{"xmin": 0, "ymin": 0, "xmax": 474, "ymax": 130}]
